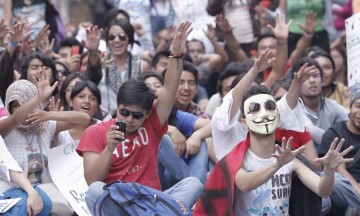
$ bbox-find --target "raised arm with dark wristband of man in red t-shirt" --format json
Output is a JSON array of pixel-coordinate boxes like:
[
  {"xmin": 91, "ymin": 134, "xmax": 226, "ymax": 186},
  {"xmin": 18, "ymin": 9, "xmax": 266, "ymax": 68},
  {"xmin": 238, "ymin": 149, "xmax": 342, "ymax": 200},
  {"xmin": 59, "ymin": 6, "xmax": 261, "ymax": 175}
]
[{"xmin": 156, "ymin": 21, "xmax": 192, "ymax": 125}]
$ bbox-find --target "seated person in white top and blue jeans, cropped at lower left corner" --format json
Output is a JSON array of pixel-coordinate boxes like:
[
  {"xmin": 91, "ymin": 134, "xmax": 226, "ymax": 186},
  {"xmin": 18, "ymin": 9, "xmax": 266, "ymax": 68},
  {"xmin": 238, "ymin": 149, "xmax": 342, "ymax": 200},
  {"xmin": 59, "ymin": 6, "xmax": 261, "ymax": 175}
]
[{"xmin": 0, "ymin": 136, "xmax": 52, "ymax": 216}]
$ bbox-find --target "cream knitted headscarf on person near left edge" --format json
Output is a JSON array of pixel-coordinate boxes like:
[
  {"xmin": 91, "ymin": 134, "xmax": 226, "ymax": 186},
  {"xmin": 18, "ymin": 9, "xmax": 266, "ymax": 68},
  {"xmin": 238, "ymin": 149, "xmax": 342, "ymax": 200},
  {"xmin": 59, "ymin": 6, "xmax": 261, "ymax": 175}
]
[{"xmin": 5, "ymin": 80, "xmax": 43, "ymax": 133}]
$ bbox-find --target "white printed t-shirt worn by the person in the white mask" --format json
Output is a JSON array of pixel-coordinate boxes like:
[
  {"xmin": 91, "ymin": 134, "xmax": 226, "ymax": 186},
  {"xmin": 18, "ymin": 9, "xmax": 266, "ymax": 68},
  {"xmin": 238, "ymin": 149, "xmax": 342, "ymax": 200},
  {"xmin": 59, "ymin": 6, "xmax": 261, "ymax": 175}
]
[{"xmin": 234, "ymin": 149, "xmax": 292, "ymax": 215}]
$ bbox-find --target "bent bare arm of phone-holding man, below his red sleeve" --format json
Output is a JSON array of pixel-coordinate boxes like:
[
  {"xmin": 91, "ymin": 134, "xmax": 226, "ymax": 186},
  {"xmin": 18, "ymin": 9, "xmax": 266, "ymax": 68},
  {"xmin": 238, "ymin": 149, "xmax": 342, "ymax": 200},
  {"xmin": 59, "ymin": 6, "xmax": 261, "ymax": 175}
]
[{"xmin": 84, "ymin": 147, "xmax": 113, "ymax": 185}]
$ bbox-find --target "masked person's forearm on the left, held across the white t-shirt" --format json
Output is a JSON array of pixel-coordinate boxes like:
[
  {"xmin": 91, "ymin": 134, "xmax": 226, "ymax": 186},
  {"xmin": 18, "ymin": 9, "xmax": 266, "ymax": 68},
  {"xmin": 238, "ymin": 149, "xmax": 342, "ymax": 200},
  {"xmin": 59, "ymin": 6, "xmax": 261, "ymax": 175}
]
[{"xmin": 235, "ymin": 161, "xmax": 280, "ymax": 193}]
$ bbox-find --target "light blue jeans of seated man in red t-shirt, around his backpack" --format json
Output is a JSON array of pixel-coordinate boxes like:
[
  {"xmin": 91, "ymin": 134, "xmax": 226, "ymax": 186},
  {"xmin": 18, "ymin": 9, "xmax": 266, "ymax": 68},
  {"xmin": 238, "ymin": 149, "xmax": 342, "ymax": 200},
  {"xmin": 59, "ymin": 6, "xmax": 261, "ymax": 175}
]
[{"xmin": 85, "ymin": 177, "xmax": 204, "ymax": 216}]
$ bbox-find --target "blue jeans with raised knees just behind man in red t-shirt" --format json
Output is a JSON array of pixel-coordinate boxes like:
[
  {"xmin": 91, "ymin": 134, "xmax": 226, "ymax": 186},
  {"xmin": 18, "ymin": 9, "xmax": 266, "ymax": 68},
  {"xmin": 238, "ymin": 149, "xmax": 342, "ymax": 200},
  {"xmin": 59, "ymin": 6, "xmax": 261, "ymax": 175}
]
[{"xmin": 158, "ymin": 135, "xmax": 209, "ymax": 189}]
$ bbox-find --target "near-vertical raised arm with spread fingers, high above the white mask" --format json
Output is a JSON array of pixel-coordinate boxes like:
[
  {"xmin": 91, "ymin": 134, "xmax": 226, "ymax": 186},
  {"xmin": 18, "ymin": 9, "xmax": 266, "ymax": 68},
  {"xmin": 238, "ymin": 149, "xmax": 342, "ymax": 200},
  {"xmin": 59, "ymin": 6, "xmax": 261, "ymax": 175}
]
[{"xmin": 264, "ymin": 14, "xmax": 292, "ymax": 89}]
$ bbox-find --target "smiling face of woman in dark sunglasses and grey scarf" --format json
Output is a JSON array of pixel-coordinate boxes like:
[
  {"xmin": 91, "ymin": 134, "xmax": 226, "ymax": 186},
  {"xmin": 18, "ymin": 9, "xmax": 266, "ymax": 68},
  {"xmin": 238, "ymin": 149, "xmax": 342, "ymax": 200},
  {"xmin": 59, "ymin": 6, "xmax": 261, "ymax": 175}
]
[{"xmin": 107, "ymin": 25, "xmax": 129, "ymax": 56}]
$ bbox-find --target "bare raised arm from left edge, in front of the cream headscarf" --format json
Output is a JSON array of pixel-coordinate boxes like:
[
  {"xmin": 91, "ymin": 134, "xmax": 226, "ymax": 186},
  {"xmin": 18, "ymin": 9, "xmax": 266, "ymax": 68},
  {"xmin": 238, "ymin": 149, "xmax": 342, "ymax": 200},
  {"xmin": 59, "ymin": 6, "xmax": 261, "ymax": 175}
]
[{"xmin": 0, "ymin": 71, "xmax": 58, "ymax": 137}]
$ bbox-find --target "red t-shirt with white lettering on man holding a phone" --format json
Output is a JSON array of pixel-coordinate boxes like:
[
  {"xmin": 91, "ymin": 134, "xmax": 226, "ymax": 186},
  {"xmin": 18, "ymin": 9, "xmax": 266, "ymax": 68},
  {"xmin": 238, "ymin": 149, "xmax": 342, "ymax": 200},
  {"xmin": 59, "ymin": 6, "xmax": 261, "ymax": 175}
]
[{"xmin": 76, "ymin": 109, "xmax": 167, "ymax": 190}]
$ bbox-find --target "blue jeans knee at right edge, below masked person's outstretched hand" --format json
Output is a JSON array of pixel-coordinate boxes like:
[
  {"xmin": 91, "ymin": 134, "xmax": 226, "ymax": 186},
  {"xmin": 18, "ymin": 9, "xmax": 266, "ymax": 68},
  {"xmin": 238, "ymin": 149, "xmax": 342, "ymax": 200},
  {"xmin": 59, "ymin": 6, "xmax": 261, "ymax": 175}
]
[{"xmin": 330, "ymin": 172, "xmax": 360, "ymax": 209}]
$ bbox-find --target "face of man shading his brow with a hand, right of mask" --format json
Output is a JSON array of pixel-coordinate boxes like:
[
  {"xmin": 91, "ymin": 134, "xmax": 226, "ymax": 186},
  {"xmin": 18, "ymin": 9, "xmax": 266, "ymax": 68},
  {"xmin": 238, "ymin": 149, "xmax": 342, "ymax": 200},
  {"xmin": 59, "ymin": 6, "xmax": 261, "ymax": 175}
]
[{"xmin": 301, "ymin": 71, "xmax": 322, "ymax": 98}]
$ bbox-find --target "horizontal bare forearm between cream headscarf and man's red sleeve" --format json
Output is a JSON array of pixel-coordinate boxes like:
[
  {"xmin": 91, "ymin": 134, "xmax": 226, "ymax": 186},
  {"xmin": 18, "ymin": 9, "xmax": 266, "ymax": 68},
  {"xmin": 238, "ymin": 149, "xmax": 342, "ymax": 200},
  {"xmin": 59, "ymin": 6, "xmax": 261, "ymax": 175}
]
[{"xmin": 44, "ymin": 111, "xmax": 91, "ymax": 125}]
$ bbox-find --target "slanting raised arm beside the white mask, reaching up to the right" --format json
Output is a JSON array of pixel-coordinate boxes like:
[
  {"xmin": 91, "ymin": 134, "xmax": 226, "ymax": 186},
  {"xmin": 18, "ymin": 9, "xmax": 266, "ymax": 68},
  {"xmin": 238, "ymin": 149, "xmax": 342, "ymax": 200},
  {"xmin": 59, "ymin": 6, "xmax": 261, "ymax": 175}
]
[{"xmin": 230, "ymin": 50, "xmax": 274, "ymax": 121}]
